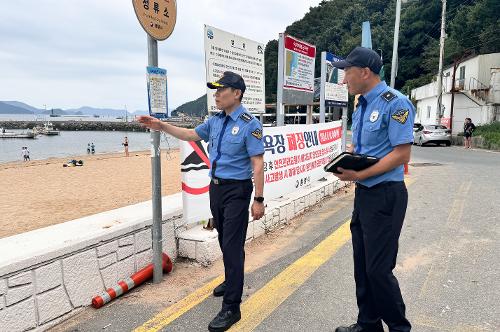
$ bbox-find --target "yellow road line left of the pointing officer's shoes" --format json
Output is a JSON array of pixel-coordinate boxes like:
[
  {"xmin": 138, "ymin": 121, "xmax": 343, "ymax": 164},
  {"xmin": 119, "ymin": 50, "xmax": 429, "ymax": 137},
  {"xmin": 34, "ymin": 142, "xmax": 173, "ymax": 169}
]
[{"xmin": 134, "ymin": 275, "xmax": 224, "ymax": 332}]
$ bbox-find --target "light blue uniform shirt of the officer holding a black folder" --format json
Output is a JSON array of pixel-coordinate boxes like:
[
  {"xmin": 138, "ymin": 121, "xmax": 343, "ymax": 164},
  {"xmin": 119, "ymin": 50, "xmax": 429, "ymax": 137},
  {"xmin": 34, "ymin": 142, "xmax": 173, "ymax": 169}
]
[{"xmin": 351, "ymin": 82, "xmax": 415, "ymax": 187}]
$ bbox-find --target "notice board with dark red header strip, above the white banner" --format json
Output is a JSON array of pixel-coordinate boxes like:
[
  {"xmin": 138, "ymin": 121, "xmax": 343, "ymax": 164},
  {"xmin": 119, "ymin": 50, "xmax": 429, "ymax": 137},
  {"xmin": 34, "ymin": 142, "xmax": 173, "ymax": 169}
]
[{"xmin": 283, "ymin": 35, "xmax": 316, "ymax": 92}]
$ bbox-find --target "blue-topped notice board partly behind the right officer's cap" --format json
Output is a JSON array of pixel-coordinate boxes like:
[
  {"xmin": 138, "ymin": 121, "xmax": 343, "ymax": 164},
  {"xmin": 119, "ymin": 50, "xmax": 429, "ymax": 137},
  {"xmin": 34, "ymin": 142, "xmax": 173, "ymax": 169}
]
[{"xmin": 325, "ymin": 53, "xmax": 348, "ymax": 107}]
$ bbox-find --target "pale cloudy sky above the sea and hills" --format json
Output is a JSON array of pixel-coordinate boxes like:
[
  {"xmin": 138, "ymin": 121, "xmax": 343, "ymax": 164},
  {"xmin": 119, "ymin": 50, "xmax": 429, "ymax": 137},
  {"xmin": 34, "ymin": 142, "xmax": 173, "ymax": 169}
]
[{"xmin": 0, "ymin": 0, "xmax": 320, "ymax": 112}]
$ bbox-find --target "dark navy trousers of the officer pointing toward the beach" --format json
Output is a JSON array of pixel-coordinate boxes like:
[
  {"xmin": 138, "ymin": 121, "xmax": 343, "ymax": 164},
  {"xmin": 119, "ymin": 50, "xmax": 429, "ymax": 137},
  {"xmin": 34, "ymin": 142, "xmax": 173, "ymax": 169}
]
[{"xmin": 209, "ymin": 180, "xmax": 253, "ymax": 311}]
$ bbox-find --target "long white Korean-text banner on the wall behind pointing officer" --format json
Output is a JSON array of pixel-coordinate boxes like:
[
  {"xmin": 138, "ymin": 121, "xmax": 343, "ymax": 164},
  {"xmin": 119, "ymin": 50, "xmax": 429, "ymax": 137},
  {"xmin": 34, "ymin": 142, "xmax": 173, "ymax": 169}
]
[{"xmin": 181, "ymin": 121, "xmax": 342, "ymax": 223}]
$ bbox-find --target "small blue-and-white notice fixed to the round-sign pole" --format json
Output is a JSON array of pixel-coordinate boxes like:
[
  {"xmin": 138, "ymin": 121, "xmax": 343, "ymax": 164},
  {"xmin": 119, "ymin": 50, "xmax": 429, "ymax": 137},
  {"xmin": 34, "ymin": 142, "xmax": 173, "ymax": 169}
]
[{"xmin": 147, "ymin": 67, "xmax": 169, "ymax": 118}]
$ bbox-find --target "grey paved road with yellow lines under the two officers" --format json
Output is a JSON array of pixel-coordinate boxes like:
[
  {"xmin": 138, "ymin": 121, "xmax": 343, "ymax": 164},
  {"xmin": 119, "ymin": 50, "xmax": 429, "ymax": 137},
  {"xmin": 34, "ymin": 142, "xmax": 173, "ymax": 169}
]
[{"xmin": 54, "ymin": 147, "xmax": 500, "ymax": 332}]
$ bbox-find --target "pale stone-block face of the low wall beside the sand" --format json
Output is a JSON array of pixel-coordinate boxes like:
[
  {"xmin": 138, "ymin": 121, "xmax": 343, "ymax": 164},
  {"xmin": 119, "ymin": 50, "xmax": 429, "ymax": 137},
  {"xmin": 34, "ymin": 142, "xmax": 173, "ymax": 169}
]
[{"xmin": 0, "ymin": 217, "xmax": 179, "ymax": 332}]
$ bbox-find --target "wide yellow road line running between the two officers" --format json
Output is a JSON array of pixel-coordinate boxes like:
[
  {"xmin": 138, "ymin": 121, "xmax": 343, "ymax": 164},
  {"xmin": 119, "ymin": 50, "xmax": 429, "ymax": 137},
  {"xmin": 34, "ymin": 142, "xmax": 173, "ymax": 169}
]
[{"xmin": 232, "ymin": 221, "xmax": 351, "ymax": 331}]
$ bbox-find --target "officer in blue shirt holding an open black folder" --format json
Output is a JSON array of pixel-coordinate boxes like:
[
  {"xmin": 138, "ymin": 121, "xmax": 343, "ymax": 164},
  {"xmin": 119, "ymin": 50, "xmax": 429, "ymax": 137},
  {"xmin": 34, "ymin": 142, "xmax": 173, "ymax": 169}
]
[{"xmin": 333, "ymin": 47, "xmax": 415, "ymax": 332}]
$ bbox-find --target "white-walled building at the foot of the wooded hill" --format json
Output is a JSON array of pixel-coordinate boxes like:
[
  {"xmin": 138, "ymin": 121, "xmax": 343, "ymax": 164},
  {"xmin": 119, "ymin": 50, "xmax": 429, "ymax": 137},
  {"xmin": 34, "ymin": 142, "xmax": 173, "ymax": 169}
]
[{"xmin": 411, "ymin": 53, "xmax": 500, "ymax": 134}]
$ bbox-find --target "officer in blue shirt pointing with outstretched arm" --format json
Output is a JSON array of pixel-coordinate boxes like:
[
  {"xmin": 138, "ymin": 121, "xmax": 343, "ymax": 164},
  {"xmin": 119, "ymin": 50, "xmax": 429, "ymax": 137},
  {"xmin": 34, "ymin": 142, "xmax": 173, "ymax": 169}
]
[{"xmin": 138, "ymin": 71, "xmax": 264, "ymax": 331}]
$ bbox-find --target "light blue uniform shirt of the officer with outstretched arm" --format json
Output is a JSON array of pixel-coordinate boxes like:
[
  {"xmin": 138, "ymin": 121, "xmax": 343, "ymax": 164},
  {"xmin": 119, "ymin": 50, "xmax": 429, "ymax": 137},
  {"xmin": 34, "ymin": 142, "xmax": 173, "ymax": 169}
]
[{"xmin": 195, "ymin": 105, "xmax": 264, "ymax": 180}]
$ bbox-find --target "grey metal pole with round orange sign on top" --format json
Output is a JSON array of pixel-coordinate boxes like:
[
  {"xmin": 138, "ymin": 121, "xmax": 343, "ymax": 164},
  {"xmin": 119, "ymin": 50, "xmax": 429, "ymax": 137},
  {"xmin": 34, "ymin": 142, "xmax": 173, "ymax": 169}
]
[{"xmin": 132, "ymin": 0, "xmax": 177, "ymax": 284}]
